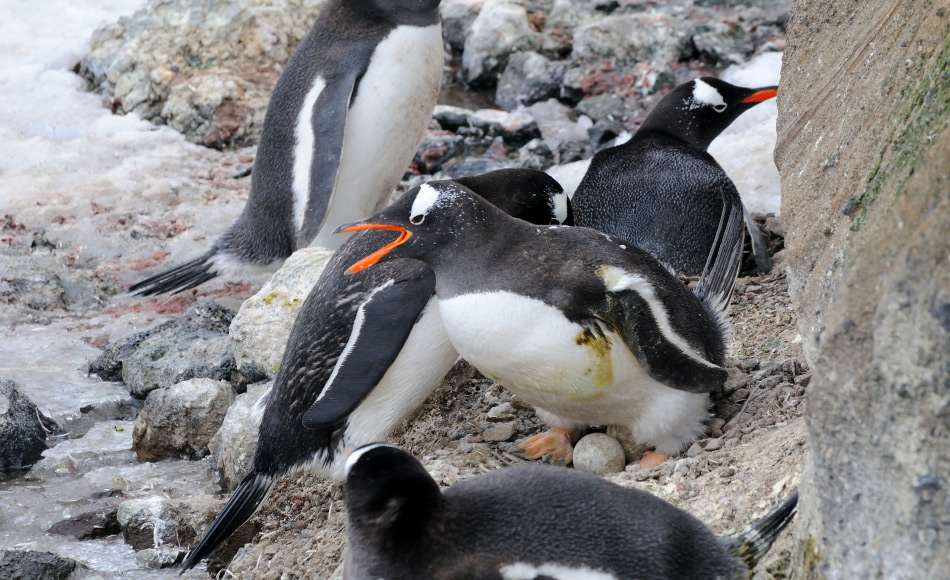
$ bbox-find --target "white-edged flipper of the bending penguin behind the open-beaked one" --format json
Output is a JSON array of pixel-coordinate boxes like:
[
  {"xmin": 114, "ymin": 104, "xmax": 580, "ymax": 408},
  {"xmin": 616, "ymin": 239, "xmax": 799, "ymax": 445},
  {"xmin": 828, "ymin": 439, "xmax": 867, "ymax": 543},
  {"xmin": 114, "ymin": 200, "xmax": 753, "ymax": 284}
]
[{"xmin": 303, "ymin": 268, "xmax": 435, "ymax": 429}]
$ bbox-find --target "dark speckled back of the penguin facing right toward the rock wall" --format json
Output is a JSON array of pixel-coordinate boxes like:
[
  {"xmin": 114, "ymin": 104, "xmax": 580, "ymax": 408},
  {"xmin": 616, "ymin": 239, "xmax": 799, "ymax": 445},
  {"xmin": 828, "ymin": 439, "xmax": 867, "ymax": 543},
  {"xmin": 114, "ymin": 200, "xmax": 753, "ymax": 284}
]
[{"xmin": 573, "ymin": 133, "xmax": 741, "ymax": 275}]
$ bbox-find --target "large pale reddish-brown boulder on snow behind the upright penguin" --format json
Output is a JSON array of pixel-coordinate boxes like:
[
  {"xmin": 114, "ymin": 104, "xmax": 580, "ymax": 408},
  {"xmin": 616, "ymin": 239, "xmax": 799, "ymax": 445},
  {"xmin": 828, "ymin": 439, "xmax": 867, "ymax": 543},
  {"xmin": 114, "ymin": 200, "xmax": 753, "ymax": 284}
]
[{"xmin": 79, "ymin": 0, "xmax": 325, "ymax": 147}]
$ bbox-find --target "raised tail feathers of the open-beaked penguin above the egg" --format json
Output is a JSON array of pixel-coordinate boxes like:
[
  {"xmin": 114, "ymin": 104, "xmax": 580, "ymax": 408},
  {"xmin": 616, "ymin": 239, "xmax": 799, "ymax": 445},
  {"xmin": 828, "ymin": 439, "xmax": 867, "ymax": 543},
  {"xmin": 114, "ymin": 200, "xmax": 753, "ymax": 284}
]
[{"xmin": 696, "ymin": 203, "xmax": 745, "ymax": 318}]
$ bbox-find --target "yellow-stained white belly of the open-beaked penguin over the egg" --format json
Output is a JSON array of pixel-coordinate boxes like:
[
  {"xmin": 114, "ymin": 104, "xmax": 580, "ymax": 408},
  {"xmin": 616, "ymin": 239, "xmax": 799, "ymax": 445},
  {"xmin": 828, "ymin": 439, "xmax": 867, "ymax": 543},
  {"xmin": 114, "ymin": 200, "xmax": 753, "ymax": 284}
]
[{"xmin": 439, "ymin": 292, "xmax": 708, "ymax": 446}]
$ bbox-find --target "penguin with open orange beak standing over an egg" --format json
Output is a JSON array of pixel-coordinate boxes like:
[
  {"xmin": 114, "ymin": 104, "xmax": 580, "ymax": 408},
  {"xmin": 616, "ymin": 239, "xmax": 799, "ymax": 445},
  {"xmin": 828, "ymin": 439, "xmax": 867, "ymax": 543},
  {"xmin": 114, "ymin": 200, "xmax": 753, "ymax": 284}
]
[{"xmin": 332, "ymin": 181, "xmax": 743, "ymax": 466}]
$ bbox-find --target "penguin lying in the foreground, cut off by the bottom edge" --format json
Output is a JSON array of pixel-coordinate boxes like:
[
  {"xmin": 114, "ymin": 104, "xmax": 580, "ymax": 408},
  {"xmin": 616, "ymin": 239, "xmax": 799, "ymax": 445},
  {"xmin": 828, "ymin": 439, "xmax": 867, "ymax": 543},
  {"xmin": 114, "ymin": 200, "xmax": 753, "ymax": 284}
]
[{"xmin": 343, "ymin": 443, "xmax": 798, "ymax": 580}]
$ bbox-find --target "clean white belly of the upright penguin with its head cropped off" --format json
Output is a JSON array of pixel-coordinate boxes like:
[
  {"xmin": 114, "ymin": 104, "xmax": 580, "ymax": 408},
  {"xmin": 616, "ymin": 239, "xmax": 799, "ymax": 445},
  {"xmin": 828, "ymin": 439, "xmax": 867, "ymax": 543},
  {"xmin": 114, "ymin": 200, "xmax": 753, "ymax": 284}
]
[{"xmin": 311, "ymin": 24, "xmax": 443, "ymax": 249}]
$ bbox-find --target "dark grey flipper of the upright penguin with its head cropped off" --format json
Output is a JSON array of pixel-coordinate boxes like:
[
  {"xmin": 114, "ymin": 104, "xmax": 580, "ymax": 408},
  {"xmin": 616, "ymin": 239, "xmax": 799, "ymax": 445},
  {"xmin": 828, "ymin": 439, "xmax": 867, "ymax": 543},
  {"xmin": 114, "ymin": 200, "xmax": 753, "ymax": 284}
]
[{"xmin": 297, "ymin": 71, "xmax": 356, "ymax": 248}]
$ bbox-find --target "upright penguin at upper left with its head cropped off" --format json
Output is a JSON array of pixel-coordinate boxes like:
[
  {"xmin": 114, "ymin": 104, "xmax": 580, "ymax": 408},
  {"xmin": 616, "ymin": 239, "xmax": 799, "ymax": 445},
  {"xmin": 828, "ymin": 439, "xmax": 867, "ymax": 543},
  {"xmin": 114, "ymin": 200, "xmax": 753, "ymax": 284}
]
[{"xmin": 129, "ymin": 0, "xmax": 443, "ymax": 295}]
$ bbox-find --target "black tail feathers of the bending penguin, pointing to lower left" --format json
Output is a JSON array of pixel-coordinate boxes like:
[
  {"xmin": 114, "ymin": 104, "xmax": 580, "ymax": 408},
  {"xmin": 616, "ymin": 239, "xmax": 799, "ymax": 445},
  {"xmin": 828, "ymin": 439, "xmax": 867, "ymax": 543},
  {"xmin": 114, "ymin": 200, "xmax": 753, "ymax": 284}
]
[{"xmin": 179, "ymin": 471, "xmax": 277, "ymax": 575}]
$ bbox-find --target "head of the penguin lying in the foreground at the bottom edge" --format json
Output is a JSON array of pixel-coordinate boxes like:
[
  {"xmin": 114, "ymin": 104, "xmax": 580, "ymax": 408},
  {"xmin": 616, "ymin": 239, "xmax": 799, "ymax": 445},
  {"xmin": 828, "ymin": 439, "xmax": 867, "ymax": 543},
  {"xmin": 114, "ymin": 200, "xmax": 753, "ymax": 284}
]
[{"xmin": 343, "ymin": 443, "xmax": 442, "ymax": 545}]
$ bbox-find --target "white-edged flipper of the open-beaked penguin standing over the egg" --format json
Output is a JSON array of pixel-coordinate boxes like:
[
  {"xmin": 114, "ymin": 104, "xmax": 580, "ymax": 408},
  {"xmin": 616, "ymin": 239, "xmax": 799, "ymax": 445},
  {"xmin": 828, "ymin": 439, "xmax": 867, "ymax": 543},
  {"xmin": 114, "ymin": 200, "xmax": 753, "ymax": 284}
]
[{"xmin": 597, "ymin": 278, "xmax": 729, "ymax": 393}]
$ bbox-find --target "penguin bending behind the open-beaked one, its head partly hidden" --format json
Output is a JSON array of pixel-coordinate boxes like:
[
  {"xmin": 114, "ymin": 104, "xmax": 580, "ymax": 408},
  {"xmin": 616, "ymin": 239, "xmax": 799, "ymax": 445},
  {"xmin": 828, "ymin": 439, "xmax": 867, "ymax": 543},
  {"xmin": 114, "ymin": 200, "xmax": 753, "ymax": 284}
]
[{"xmin": 182, "ymin": 169, "xmax": 570, "ymax": 569}]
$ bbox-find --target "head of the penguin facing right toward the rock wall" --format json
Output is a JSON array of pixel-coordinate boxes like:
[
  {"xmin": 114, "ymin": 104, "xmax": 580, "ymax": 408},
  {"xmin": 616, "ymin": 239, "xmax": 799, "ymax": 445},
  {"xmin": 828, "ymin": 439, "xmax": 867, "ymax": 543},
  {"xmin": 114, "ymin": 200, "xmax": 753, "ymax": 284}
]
[{"xmin": 637, "ymin": 77, "xmax": 778, "ymax": 149}]
